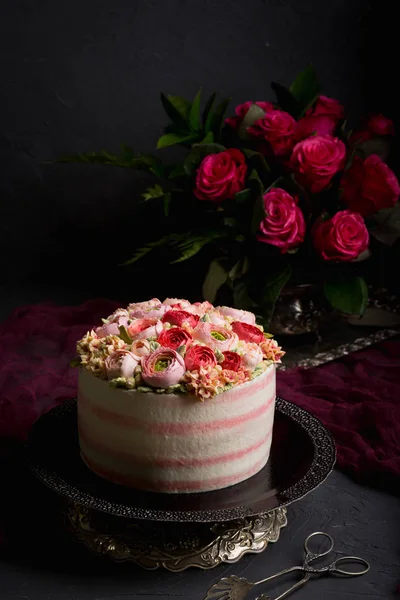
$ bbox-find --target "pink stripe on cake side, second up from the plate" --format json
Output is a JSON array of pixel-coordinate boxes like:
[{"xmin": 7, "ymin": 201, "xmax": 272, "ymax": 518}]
[{"xmin": 79, "ymin": 428, "xmax": 272, "ymax": 468}]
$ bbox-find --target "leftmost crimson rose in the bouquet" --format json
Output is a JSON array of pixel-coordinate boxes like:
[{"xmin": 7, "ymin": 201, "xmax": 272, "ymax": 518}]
[{"xmin": 194, "ymin": 148, "xmax": 247, "ymax": 202}]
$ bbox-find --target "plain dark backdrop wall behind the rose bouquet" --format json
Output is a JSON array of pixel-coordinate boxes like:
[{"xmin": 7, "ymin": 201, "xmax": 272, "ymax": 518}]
[{"xmin": 0, "ymin": 0, "xmax": 397, "ymax": 298}]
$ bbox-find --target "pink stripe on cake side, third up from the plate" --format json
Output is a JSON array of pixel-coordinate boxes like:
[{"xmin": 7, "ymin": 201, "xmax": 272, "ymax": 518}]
[{"xmin": 79, "ymin": 394, "xmax": 275, "ymax": 436}]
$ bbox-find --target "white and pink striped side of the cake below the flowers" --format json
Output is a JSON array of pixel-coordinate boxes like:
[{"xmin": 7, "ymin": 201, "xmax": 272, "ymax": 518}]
[{"xmin": 78, "ymin": 364, "xmax": 275, "ymax": 493}]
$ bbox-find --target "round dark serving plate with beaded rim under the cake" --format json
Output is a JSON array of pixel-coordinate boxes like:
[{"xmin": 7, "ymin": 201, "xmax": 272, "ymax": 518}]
[{"xmin": 26, "ymin": 398, "xmax": 336, "ymax": 523}]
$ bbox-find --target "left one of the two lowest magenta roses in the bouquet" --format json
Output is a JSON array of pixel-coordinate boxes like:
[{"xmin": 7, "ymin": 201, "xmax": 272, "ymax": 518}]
[{"xmin": 257, "ymin": 188, "xmax": 306, "ymax": 253}]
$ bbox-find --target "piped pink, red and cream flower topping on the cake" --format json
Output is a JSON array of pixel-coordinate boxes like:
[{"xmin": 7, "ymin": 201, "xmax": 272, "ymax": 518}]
[{"xmin": 73, "ymin": 298, "xmax": 285, "ymax": 401}]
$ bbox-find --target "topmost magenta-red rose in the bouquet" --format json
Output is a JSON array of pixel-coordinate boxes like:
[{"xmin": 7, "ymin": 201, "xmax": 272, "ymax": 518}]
[{"xmin": 295, "ymin": 96, "xmax": 344, "ymax": 140}]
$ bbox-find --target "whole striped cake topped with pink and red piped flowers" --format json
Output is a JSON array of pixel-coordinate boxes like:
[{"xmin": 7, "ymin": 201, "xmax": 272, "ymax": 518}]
[{"xmin": 74, "ymin": 298, "xmax": 284, "ymax": 493}]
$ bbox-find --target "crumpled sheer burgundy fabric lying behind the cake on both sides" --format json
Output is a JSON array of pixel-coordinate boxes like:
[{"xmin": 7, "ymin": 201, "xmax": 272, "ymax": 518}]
[{"xmin": 0, "ymin": 300, "xmax": 400, "ymax": 488}]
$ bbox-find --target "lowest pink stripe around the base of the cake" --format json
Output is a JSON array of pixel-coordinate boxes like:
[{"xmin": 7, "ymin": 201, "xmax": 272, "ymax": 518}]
[{"xmin": 81, "ymin": 453, "xmax": 266, "ymax": 492}]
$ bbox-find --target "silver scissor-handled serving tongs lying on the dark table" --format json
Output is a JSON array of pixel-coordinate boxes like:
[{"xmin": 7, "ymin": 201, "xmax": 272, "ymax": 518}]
[{"xmin": 205, "ymin": 531, "xmax": 370, "ymax": 600}]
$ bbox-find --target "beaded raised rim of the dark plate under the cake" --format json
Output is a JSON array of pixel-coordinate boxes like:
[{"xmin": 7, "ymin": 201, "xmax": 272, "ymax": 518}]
[{"xmin": 25, "ymin": 396, "xmax": 336, "ymax": 523}]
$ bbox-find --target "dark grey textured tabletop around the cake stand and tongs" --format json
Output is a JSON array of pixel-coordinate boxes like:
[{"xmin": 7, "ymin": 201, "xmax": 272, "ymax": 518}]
[{"xmin": 0, "ymin": 290, "xmax": 400, "ymax": 600}]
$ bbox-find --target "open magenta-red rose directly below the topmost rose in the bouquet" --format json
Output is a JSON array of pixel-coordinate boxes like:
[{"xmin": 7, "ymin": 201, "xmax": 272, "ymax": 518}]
[{"xmin": 290, "ymin": 135, "xmax": 346, "ymax": 194}]
